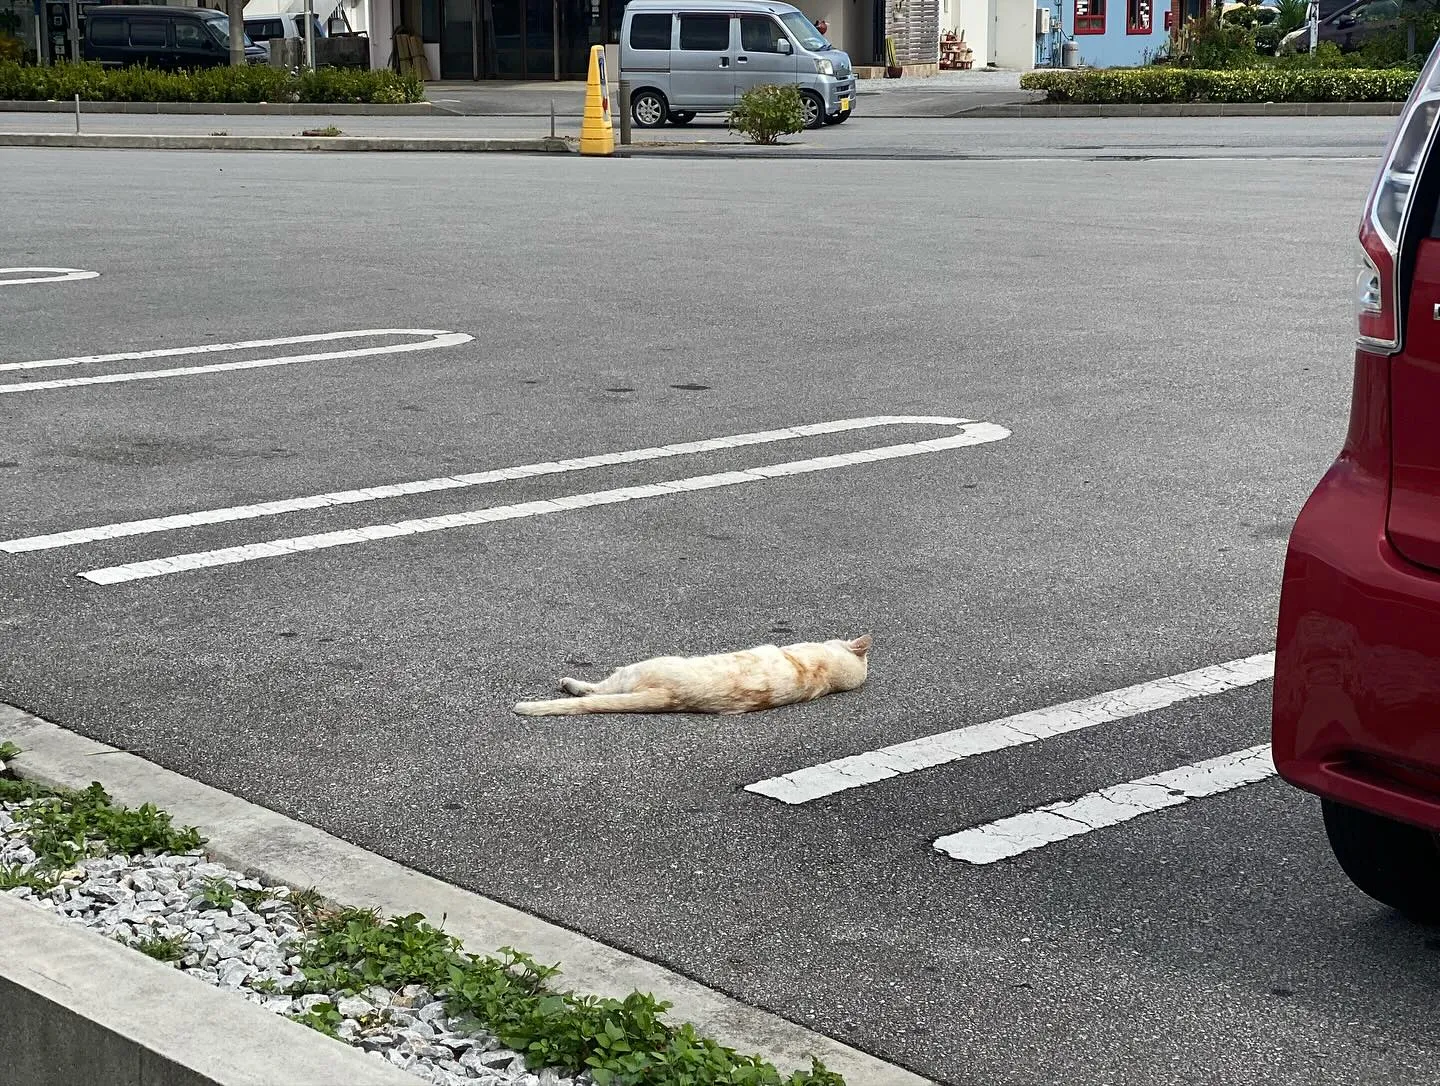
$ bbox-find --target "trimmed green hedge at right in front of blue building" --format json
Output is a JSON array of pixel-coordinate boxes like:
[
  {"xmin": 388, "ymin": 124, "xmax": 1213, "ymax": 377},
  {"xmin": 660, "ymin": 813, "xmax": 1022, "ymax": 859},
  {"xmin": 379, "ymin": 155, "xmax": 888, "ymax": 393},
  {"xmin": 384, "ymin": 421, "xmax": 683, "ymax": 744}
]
[{"xmin": 1020, "ymin": 68, "xmax": 1416, "ymax": 105}]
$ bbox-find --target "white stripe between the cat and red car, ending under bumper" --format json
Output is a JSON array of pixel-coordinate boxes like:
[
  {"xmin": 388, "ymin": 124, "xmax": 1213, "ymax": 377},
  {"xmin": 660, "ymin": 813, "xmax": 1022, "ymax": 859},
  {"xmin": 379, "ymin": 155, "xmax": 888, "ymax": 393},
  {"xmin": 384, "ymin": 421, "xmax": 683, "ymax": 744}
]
[{"xmin": 746, "ymin": 652, "xmax": 1274, "ymax": 804}]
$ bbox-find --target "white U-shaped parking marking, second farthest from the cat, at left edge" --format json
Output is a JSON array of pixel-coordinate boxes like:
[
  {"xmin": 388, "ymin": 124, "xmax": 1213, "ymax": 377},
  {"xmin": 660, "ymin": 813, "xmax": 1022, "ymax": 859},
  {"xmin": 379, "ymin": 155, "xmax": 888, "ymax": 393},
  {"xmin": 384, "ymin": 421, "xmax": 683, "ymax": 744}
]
[{"xmin": 0, "ymin": 328, "xmax": 474, "ymax": 395}]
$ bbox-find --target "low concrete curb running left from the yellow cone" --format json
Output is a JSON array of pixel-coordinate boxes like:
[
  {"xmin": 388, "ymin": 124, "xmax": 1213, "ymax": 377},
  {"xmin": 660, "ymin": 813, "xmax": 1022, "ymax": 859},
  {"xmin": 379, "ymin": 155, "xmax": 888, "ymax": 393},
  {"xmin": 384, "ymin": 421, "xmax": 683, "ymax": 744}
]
[{"xmin": 0, "ymin": 133, "xmax": 576, "ymax": 154}]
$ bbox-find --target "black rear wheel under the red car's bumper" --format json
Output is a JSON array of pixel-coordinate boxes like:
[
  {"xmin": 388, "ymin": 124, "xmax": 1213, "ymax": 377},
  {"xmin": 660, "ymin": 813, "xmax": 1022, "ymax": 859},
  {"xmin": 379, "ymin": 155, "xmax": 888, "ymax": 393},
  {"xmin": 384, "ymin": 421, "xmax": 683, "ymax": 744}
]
[{"xmin": 1320, "ymin": 799, "xmax": 1440, "ymax": 923}]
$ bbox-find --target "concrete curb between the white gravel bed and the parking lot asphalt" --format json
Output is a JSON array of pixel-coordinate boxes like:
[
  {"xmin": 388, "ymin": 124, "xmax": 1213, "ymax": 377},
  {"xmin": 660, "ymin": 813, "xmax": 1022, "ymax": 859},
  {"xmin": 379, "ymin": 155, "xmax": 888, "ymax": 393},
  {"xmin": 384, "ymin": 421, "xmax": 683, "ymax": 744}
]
[{"xmin": 0, "ymin": 704, "xmax": 932, "ymax": 1086}]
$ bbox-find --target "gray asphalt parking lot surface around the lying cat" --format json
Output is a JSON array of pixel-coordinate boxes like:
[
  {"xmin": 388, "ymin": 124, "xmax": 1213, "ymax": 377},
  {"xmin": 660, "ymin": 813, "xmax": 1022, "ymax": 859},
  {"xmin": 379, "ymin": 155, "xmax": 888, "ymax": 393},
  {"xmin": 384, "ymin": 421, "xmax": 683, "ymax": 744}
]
[{"xmin": 0, "ymin": 122, "xmax": 1440, "ymax": 1086}]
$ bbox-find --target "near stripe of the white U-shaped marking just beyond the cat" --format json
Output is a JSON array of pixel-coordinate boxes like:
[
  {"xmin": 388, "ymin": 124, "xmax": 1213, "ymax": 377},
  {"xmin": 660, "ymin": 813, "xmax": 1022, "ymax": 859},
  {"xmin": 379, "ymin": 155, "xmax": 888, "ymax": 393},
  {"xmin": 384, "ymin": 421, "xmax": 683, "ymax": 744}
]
[{"xmin": 81, "ymin": 422, "xmax": 1009, "ymax": 585}]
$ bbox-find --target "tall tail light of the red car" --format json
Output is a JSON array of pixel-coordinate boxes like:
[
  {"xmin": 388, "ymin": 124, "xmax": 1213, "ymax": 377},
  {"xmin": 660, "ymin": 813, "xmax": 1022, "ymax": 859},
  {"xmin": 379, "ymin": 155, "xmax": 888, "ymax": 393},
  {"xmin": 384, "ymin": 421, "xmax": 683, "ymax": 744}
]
[{"xmin": 1355, "ymin": 49, "xmax": 1440, "ymax": 353}]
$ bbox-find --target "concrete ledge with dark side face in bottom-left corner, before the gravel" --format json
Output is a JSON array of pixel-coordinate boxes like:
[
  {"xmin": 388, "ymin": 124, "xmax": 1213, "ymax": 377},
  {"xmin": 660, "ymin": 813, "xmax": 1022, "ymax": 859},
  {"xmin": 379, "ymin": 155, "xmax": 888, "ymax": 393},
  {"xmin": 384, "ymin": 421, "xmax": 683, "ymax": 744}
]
[{"xmin": 0, "ymin": 894, "xmax": 419, "ymax": 1086}]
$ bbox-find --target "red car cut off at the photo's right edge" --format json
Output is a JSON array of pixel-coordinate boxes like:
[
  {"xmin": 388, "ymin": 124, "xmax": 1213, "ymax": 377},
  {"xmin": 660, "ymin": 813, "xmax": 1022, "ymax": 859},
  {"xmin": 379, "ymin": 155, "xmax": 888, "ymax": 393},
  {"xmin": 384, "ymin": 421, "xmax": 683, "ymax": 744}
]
[{"xmin": 1273, "ymin": 49, "xmax": 1440, "ymax": 920}]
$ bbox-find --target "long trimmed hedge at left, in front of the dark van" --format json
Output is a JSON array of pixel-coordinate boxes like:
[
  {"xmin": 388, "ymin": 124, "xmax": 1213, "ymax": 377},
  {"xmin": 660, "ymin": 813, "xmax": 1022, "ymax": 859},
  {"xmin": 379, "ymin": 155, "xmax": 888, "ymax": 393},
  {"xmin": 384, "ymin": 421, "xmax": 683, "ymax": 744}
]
[{"xmin": 0, "ymin": 62, "xmax": 425, "ymax": 102}]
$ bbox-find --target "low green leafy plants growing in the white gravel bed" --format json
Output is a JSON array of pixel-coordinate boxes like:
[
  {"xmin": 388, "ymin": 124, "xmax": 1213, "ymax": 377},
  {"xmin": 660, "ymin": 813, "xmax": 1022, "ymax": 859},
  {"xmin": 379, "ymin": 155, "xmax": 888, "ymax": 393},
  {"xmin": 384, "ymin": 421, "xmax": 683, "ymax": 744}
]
[{"xmin": 0, "ymin": 746, "xmax": 845, "ymax": 1086}]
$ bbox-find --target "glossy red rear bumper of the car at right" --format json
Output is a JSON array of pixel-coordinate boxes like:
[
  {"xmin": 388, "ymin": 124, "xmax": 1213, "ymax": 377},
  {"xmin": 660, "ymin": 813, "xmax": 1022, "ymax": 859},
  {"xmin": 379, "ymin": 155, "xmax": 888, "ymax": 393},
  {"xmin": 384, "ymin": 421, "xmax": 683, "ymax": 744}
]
[{"xmin": 1273, "ymin": 359, "xmax": 1440, "ymax": 831}]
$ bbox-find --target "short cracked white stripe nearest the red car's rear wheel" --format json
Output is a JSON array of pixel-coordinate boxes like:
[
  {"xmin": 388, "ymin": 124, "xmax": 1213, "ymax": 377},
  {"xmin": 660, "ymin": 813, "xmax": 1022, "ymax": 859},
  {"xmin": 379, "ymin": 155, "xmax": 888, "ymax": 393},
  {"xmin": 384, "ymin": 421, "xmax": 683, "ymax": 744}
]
[{"xmin": 935, "ymin": 743, "xmax": 1274, "ymax": 864}]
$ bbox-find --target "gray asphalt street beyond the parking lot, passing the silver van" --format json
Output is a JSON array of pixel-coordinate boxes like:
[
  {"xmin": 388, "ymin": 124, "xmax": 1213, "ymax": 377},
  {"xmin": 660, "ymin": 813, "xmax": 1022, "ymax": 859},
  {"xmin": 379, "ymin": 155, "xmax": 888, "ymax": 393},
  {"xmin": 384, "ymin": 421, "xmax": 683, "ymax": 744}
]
[{"xmin": 0, "ymin": 114, "xmax": 1395, "ymax": 158}]
